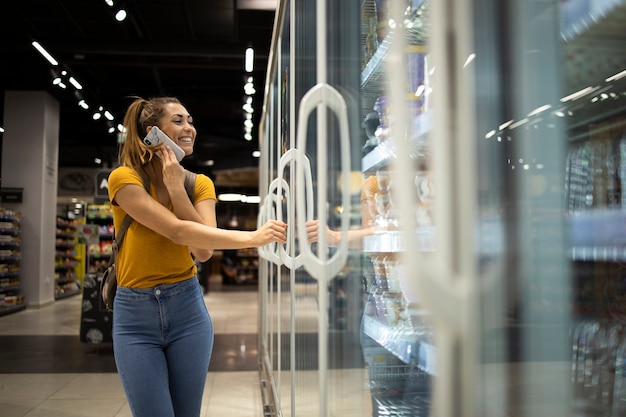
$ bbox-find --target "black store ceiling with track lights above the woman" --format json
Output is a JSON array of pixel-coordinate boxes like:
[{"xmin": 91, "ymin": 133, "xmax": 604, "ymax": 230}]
[{"xmin": 0, "ymin": 0, "xmax": 275, "ymax": 174}]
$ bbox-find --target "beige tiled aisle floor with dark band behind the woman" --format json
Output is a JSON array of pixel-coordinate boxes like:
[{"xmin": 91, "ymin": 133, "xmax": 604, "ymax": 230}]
[{"xmin": 0, "ymin": 276, "xmax": 263, "ymax": 417}]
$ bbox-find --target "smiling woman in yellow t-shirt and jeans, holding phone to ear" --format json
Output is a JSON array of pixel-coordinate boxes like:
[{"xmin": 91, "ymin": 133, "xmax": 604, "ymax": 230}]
[{"xmin": 108, "ymin": 97, "xmax": 287, "ymax": 417}]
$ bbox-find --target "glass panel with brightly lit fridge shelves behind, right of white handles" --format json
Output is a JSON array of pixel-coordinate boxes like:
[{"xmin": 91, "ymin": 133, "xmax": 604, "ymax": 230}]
[{"xmin": 359, "ymin": 0, "xmax": 435, "ymax": 416}]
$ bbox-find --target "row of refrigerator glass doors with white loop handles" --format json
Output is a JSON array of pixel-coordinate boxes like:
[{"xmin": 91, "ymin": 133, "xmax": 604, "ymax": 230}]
[{"xmin": 259, "ymin": 0, "xmax": 626, "ymax": 417}]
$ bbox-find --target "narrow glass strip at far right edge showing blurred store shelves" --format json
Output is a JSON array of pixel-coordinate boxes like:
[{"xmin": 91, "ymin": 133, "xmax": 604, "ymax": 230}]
[{"xmin": 559, "ymin": 0, "xmax": 626, "ymax": 416}]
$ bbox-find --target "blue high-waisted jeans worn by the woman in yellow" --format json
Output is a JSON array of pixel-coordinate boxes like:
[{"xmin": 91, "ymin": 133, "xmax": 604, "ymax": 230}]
[{"xmin": 113, "ymin": 277, "xmax": 213, "ymax": 417}]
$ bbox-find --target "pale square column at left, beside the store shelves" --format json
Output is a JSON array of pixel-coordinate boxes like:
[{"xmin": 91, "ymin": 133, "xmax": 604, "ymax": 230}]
[{"xmin": 2, "ymin": 91, "xmax": 59, "ymax": 306}]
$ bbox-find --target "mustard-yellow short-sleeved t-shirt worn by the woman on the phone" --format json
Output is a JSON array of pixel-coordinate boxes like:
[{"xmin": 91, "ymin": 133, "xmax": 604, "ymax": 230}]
[{"xmin": 108, "ymin": 166, "xmax": 216, "ymax": 288}]
